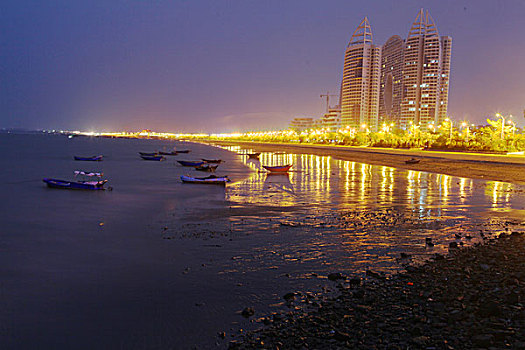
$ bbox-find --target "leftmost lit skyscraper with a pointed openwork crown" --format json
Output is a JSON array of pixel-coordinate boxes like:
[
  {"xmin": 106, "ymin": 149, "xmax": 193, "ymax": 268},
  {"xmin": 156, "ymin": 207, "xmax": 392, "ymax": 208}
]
[{"xmin": 341, "ymin": 17, "xmax": 381, "ymax": 131}]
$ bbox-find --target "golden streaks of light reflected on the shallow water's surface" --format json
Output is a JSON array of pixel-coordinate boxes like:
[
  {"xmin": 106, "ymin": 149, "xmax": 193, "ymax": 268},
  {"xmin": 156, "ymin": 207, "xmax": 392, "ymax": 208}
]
[{"xmin": 199, "ymin": 147, "xmax": 522, "ymax": 273}]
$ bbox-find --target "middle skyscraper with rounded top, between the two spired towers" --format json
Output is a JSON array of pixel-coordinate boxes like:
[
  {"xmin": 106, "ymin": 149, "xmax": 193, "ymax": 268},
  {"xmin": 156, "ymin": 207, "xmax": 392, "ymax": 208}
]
[{"xmin": 379, "ymin": 35, "xmax": 405, "ymax": 125}]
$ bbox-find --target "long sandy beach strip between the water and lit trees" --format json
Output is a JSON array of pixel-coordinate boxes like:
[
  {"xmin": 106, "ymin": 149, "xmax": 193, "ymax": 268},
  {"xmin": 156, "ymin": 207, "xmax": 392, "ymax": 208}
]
[{"xmin": 203, "ymin": 140, "xmax": 525, "ymax": 185}]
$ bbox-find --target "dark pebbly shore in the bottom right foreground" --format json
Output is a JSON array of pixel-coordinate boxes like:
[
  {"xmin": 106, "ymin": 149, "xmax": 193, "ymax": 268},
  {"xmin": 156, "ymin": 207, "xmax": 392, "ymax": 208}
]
[{"xmin": 235, "ymin": 232, "xmax": 525, "ymax": 349}]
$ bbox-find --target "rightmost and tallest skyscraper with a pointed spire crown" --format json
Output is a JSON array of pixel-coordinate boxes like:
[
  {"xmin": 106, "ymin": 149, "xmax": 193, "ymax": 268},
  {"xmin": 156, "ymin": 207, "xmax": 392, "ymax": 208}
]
[{"xmin": 399, "ymin": 9, "xmax": 452, "ymax": 130}]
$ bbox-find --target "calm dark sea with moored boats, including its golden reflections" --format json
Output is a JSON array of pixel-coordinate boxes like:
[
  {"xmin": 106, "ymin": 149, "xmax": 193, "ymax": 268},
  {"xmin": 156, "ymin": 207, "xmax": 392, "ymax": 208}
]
[{"xmin": 0, "ymin": 134, "xmax": 525, "ymax": 349}]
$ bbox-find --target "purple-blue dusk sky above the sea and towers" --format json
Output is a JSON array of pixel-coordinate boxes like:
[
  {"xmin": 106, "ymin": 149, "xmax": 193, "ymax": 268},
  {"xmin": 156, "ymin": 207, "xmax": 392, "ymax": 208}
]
[{"xmin": 0, "ymin": 0, "xmax": 525, "ymax": 132}]
